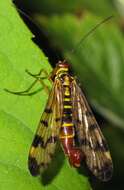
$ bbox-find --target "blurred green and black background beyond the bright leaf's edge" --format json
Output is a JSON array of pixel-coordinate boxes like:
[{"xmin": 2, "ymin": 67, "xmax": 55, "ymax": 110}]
[{"xmin": 0, "ymin": 0, "xmax": 124, "ymax": 190}]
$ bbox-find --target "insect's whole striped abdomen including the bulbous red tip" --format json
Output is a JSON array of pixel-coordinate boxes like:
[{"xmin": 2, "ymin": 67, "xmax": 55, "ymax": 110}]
[{"xmin": 60, "ymin": 76, "xmax": 81, "ymax": 167}]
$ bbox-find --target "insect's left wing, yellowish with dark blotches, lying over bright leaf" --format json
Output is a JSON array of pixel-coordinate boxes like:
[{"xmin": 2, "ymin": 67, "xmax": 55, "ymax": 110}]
[{"xmin": 28, "ymin": 79, "xmax": 62, "ymax": 176}]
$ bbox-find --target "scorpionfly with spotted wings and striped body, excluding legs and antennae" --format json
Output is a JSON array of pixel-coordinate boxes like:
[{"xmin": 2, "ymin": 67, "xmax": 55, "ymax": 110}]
[{"xmin": 28, "ymin": 61, "xmax": 113, "ymax": 181}]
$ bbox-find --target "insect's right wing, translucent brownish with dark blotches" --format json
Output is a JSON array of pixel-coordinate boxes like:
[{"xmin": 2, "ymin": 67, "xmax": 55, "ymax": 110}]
[{"xmin": 71, "ymin": 80, "xmax": 113, "ymax": 181}]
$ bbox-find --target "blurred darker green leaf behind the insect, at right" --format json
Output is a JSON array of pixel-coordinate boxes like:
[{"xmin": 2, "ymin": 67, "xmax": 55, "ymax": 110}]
[{"xmin": 36, "ymin": 14, "xmax": 124, "ymax": 128}]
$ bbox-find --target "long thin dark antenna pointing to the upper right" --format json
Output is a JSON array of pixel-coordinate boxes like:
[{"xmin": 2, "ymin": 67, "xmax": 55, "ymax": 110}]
[{"xmin": 70, "ymin": 15, "xmax": 114, "ymax": 54}]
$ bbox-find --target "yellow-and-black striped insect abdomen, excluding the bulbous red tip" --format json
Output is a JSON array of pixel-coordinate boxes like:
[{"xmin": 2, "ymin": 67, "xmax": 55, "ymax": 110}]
[{"xmin": 60, "ymin": 76, "xmax": 75, "ymax": 154}]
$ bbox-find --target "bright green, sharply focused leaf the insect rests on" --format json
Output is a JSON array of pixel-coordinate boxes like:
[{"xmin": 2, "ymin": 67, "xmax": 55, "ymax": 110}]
[{"xmin": 0, "ymin": 0, "xmax": 91, "ymax": 190}]
